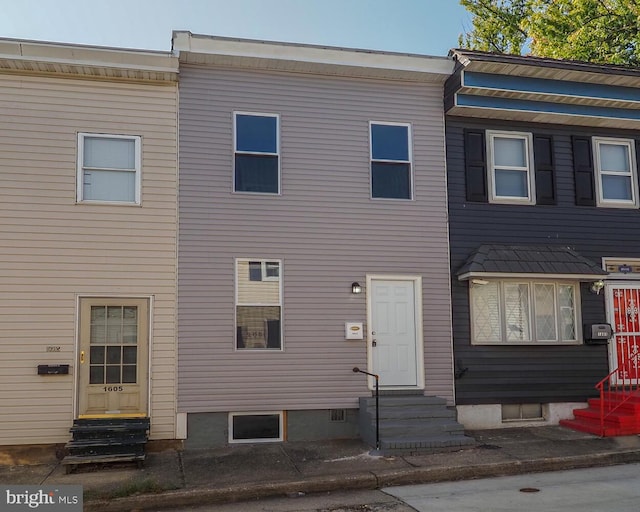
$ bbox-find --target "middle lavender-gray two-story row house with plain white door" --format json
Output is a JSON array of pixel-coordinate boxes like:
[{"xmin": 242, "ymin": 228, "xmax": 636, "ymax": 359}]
[{"xmin": 173, "ymin": 32, "xmax": 472, "ymax": 447}]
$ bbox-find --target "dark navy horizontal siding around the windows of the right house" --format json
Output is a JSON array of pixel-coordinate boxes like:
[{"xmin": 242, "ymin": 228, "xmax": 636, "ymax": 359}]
[{"xmin": 447, "ymin": 117, "xmax": 640, "ymax": 404}]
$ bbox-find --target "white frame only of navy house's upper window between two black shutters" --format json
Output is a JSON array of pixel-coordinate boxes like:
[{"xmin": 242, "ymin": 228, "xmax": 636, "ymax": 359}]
[{"xmin": 486, "ymin": 130, "xmax": 536, "ymax": 204}]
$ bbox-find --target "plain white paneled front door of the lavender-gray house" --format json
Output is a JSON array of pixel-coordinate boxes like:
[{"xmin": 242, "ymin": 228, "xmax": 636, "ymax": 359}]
[{"xmin": 367, "ymin": 278, "xmax": 422, "ymax": 388}]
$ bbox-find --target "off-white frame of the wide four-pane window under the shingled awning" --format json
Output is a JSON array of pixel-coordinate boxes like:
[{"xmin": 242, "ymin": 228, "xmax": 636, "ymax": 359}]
[{"xmin": 469, "ymin": 277, "xmax": 582, "ymax": 346}]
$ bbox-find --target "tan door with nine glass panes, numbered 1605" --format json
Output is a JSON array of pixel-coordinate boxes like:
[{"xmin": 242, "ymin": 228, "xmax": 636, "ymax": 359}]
[{"xmin": 78, "ymin": 298, "xmax": 149, "ymax": 418}]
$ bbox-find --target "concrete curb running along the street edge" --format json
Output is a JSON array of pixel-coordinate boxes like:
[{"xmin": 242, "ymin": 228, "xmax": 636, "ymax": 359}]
[{"xmin": 84, "ymin": 450, "xmax": 640, "ymax": 512}]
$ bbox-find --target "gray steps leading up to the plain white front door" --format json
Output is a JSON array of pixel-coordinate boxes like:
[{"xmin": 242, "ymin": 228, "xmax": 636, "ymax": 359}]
[{"xmin": 359, "ymin": 391, "xmax": 475, "ymax": 455}]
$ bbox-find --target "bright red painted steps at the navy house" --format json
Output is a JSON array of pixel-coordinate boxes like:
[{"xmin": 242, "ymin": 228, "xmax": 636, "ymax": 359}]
[{"xmin": 560, "ymin": 392, "xmax": 640, "ymax": 437}]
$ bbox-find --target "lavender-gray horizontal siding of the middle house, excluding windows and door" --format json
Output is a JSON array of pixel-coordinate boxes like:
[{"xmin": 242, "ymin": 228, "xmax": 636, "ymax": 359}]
[{"xmin": 178, "ymin": 66, "xmax": 453, "ymax": 412}]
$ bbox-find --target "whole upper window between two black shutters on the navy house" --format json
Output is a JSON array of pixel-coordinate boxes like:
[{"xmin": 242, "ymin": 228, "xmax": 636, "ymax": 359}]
[{"xmin": 487, "ymin": 131, "xmax": 535, "ymax": 204}]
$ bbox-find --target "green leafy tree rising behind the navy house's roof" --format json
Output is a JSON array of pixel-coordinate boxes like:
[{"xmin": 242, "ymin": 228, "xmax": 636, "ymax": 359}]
[{"xmin": 460, "ymin": 0, "xmax": 640, "ymax": 66}]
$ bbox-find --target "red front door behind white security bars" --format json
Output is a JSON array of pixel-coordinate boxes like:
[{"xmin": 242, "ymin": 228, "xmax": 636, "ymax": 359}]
[{"xmin": 607, "ymin": 282, "xmax": 640, "ymax": 385}]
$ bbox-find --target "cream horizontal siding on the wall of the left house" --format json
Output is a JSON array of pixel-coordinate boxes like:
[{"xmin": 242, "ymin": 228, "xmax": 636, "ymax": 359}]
[{"xmin": 0, "ymin": 74, "xmax": 177, "ymax": 445}]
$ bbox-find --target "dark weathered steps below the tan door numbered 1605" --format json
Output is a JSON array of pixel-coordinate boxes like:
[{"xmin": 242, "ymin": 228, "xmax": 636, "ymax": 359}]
[{"xmin": 62, "ymin": 418, "xmax": 150, "ymax": 473}]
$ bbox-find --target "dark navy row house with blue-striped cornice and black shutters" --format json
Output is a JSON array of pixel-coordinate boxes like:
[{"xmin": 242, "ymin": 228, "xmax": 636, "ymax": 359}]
[{"xmin": 445, "ymin": 50, "xmax": 640, "ymax": 428}]
